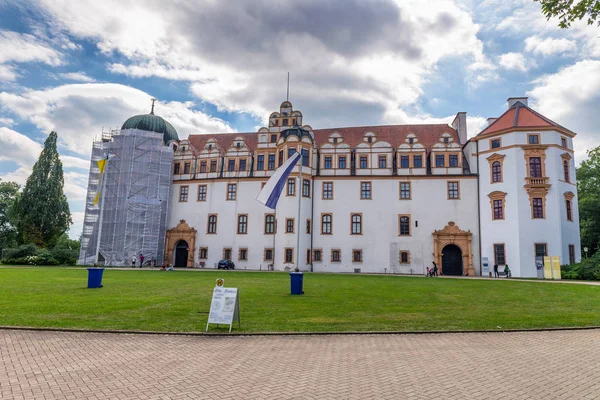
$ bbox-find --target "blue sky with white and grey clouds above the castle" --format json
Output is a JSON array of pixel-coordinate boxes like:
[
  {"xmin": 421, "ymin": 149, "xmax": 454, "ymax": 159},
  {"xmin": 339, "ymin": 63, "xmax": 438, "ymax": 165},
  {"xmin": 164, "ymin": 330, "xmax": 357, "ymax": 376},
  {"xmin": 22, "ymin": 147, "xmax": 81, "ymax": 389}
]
[{"xmin": 0, "ymin": 0, "xmax": 600, "ymax": 237}]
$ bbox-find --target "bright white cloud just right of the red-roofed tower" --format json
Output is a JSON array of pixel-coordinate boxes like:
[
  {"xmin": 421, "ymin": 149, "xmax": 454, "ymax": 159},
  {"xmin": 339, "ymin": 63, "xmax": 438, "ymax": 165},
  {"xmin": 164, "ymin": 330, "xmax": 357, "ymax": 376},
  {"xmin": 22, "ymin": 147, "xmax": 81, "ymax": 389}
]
[{"xmin": 528, "ymin": 60, "xmax": 600, "ymax": 161}]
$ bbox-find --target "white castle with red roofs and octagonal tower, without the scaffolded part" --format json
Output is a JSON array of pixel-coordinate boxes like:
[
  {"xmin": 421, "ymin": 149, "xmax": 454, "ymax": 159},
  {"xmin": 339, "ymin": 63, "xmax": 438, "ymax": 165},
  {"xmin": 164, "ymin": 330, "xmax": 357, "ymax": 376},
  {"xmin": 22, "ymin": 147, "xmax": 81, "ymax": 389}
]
[{"xmin": 82, "ymin": 98, "xmax": 581, "ymax": 277}]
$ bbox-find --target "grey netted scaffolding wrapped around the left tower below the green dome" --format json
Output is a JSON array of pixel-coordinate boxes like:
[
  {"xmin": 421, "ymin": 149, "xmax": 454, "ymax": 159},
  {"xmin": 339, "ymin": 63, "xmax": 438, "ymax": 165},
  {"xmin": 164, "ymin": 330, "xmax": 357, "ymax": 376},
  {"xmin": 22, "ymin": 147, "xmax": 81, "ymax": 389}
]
[{"xmin": 79, "ymin": 129, "xmax": 173, "ymax": 266}]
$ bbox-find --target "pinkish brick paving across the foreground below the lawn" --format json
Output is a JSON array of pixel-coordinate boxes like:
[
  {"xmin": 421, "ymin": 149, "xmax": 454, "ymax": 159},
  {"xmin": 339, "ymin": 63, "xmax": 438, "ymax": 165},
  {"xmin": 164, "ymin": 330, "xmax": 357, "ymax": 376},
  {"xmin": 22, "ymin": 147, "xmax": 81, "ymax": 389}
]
[{"xmin": 0, "ymin": 330, "xmax": 600, "ymax": 400}]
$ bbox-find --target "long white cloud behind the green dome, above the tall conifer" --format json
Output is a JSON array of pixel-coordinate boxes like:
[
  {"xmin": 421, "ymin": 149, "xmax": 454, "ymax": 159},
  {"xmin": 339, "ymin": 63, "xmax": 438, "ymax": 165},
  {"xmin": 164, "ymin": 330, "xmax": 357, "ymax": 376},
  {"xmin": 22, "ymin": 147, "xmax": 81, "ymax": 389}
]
[{"xmin": 0, "ymin": 83, "xmax": 232, "ymax": 155}]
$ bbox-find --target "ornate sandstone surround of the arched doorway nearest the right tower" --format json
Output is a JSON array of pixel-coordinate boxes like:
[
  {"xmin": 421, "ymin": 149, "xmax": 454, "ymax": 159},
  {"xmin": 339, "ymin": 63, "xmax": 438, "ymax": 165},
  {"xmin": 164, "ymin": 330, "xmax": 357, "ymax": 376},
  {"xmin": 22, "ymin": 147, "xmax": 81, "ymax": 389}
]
[{"xmin": 433, "ymin": 221, "xmax": 475, "ymax": 276}]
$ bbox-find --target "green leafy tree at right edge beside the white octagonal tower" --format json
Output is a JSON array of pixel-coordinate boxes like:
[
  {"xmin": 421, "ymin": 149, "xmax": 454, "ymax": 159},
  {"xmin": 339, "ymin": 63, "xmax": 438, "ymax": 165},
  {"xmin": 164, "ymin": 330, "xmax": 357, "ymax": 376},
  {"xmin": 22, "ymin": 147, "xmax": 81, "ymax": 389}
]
[{"xmin": 577, "ymin": 146, "xmax": 600, "ymax": 254}]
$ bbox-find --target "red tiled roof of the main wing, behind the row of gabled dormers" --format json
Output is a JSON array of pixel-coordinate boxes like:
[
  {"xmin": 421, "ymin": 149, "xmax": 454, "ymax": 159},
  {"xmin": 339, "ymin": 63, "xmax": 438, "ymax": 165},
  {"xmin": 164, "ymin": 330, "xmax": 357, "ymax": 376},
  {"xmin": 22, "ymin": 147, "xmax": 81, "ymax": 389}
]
[{"xmin": 188, "ymin": 124, "xmax": 460, "ymax": 150}]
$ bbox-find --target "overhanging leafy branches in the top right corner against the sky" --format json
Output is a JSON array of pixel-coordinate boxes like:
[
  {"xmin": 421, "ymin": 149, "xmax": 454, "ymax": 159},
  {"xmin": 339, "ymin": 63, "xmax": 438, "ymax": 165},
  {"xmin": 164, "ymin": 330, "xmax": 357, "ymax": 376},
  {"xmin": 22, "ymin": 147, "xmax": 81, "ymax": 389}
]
[{"xmin": 534, "ymin": 0, "xmax": 600, "ymax": 29}]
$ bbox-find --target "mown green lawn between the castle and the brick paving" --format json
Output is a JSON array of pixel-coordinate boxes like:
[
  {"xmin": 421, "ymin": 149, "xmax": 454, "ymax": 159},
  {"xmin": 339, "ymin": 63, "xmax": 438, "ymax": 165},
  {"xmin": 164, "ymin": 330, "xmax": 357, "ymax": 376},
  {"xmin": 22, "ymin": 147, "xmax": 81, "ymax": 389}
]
[{"xmin": 0, "ymin": 268, "xmax": 600, "ymax": 332}]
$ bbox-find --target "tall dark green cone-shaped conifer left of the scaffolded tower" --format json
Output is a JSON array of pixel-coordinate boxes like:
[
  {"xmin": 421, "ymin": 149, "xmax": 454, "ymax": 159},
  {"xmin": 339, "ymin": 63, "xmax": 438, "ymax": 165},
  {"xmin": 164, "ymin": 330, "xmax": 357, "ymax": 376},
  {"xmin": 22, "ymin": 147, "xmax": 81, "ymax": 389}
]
[{"xmin": 15, "ymin": 132, "xmax": 73, "ymax": 247}]
